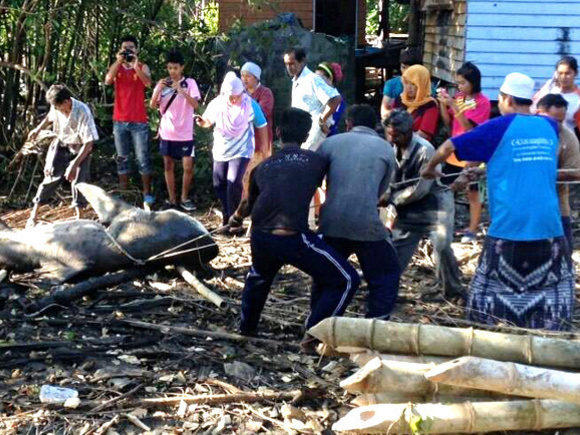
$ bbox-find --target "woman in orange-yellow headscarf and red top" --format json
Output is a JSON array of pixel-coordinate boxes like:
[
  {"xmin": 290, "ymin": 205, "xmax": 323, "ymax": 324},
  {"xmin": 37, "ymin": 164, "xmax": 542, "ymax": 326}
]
[{"xmin": 394, "ymin": 65, "xmax": 439, "ymax": 141}]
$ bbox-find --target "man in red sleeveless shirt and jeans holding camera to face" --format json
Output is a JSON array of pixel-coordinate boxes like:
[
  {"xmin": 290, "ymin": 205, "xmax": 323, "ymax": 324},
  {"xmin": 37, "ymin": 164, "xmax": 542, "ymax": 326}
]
[{"xmin": 105, "ymin": 35, "xmax": 154, "ymax": 206}]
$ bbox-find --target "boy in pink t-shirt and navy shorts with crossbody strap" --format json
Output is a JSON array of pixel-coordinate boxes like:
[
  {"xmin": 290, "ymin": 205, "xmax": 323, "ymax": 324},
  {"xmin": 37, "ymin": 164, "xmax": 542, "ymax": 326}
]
[{"xmin": 151, "ymin": 51, "xmax": 201, "ymax": 211}]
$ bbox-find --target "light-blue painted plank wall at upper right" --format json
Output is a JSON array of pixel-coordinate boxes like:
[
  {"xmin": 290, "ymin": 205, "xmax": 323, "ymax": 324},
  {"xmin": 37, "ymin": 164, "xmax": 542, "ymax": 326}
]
[{"xmin": 465, "ymin": 0, "xmax": 580, "ymax": 99}]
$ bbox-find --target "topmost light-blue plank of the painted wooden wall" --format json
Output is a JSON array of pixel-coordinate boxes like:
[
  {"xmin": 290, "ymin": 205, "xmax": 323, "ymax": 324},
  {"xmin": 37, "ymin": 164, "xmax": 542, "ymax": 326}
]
[{"xmin": 469, "ymin": 0, "xmax": 580, "ymax": 17}]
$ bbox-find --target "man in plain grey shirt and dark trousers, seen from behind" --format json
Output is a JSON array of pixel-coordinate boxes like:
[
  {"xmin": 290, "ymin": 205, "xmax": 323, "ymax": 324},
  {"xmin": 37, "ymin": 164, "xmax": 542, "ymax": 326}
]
[{"xmin": 318, "ymin": 104, "xmax": 400, "ymax": 318}]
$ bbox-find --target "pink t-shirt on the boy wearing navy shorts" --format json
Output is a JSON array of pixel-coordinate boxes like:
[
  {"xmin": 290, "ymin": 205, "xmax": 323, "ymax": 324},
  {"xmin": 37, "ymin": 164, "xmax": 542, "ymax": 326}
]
[{"xmin": 156, "ymin": 78, "xmax": 201, "ymax": 142}]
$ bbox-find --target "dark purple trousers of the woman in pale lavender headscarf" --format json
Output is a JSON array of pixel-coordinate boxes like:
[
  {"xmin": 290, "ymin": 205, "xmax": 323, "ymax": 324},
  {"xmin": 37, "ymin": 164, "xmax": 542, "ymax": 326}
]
[{"xmin": 213, "ymin": 157, "xmax": 250, "ymax": 225}]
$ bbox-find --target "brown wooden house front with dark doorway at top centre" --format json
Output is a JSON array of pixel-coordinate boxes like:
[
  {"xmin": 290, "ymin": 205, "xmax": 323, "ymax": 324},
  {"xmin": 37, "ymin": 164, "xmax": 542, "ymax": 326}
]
[{"xmin": 219, "ymin": 0, "xmax": 366, "ymax": 44}]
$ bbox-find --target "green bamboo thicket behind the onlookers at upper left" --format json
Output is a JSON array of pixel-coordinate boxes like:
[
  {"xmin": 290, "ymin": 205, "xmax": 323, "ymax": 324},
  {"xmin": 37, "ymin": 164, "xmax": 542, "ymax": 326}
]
[{"xmin": 0, "ymin": 0, "xmax": 218, "ymax": 154}]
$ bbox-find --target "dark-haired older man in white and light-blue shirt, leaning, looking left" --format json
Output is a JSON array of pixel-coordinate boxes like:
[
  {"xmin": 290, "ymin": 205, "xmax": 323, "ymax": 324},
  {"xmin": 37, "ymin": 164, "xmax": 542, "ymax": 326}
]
[{"xmin": 284, "ymin": 48, "xmax": 342, "ymax": 151}]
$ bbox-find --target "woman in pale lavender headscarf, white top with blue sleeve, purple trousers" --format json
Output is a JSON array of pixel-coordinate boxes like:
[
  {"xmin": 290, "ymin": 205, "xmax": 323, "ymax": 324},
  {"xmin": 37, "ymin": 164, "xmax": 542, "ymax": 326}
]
[{"xmin": 196, "ymin": 71, "xmax": 268, "ymax": 230}]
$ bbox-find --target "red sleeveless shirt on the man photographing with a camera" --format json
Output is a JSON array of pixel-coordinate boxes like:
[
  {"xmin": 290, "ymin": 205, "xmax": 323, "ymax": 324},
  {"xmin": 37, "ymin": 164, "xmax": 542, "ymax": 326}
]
[{"xmin": 113, "ymin": 64, "xmax": 147, "ymax": 122}]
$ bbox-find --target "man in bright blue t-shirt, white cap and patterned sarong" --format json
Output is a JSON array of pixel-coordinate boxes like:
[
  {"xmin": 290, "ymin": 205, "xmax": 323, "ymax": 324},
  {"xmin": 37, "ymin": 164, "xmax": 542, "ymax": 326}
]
[{"xmin": 422, "ymin": 73, "xmax": 575, "ymax": 329}]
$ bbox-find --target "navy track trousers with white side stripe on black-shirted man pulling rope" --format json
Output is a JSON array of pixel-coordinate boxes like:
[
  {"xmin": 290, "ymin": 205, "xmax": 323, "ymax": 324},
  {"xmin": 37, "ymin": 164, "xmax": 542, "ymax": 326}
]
[{"xmin": 240, "ymin": 231, "xmax": 360, "ymax": 333}]
